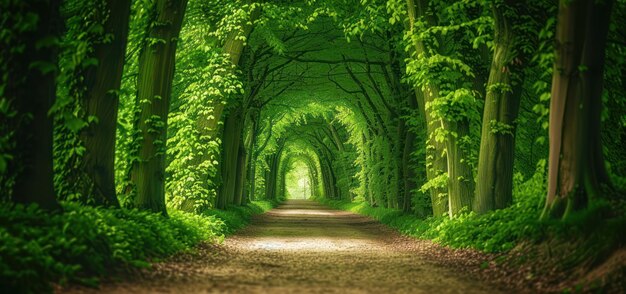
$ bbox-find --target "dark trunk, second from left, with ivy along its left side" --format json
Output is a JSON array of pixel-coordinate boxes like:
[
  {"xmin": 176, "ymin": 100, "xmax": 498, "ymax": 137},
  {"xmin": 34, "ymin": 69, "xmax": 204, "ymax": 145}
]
[{"xmin": 81, "ymin": 0, "xmax": 131, "ymax": 207}]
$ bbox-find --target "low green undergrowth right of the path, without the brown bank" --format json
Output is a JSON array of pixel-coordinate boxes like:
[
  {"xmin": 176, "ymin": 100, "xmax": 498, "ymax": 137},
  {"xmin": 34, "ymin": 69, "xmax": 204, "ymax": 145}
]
[{"xmin": 318, "ymin": 164, "xmax": 626, "ymax": 253}]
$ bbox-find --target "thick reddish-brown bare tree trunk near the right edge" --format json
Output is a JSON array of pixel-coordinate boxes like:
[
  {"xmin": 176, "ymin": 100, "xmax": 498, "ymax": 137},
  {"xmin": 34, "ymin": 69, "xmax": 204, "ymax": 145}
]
[{"xmin": 542, "ymin": 0, "xmax": 613, "ymax": 219}]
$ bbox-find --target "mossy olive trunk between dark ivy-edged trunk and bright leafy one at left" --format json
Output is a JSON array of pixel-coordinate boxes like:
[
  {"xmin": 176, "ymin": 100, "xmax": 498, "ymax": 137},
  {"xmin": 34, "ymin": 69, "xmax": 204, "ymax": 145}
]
[{"xmin": 131, "ymin": 0, "xmax": 187, "ymax": 214}]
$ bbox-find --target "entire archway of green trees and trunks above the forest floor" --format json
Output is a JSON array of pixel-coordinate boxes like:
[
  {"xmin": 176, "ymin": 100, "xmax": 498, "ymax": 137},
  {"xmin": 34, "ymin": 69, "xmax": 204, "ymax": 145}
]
[{"xmin": 0, "ymin": 0, "xmax": 626, "ymax": 292}]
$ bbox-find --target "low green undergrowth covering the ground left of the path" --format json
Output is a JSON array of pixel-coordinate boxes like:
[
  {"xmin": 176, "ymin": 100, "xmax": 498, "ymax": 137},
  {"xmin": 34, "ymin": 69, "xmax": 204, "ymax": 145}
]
[{"xmin": 0, "ymin": 201, "xmax": 272, "ymax": 293}]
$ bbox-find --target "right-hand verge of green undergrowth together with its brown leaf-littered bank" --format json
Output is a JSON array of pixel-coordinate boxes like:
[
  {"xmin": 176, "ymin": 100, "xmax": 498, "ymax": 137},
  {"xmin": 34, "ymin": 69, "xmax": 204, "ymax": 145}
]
[{"xmin": 317, "ymin": 166, "xmax": 626, "ymax": 292}]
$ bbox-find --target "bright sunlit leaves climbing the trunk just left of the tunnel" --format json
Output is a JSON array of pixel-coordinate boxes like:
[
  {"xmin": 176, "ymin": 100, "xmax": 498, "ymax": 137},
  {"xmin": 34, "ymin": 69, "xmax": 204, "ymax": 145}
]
[{"xmin": 166, "ymin": 43, "xmax": 243, "ymax": 212}]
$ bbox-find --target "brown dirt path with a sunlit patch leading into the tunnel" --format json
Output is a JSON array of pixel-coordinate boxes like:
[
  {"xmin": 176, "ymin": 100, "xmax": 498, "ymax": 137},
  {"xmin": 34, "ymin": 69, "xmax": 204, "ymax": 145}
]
[{"xmin": 67, "ymin": 200, "xmax": 499, "ymax": 293}]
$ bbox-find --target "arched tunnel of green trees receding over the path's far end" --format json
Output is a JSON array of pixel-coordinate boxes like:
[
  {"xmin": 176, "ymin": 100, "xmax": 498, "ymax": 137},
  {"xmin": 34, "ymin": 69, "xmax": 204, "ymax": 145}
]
[{"xmin": 185, "ymin": 8, "xmax": 432, "ymax": 215}]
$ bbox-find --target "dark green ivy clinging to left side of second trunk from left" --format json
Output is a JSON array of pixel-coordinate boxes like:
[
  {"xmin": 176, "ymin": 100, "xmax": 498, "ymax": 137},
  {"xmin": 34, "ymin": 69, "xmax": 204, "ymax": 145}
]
[{"xmin": 50, "ymin": 0, "xmax": 111, "ymax": 203}]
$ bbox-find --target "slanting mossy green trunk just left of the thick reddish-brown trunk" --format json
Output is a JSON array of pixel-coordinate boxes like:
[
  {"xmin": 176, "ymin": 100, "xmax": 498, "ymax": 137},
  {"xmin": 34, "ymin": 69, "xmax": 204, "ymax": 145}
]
[{"xmin": 474, "ymin": 0, "xmax": 526, "ymax": 213}]
